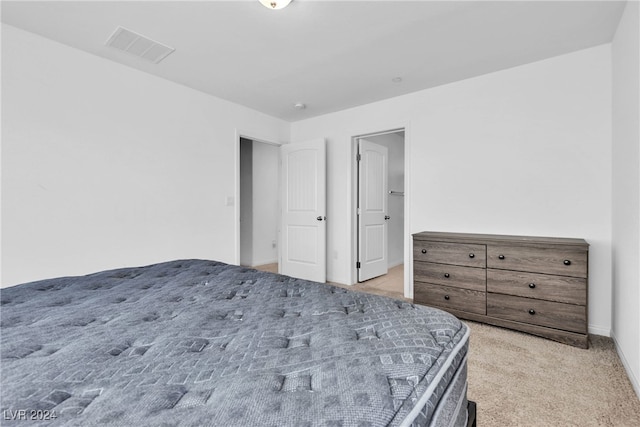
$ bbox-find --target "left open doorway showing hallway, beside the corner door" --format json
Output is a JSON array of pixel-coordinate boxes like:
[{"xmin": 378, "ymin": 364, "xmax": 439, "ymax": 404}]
[{"xmin": 239, "ymin": 137, "xmax": 280, "ymax": 273}]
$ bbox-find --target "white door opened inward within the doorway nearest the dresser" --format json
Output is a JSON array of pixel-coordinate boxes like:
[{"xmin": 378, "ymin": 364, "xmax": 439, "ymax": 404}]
[{"xmin": 358, "ymin": 139, "xmax": 389, "ymax": 282}]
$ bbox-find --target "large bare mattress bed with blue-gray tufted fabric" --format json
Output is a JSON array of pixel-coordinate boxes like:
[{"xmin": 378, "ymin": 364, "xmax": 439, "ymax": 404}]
[{"xmin": 0, "ymin": 260, "xmax": 473, "ymax": 426}]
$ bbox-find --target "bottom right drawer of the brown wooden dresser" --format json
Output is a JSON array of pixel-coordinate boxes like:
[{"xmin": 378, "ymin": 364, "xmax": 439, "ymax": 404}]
[{"xmin": 487, "ymin": 293, "xmax": 587, "ymax": 334}]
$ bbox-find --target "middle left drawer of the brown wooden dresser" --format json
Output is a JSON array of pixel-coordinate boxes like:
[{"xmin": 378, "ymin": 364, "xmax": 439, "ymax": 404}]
[{"xmin": 413, "ymin": 261, "xmax": 486, "ymax": 292}]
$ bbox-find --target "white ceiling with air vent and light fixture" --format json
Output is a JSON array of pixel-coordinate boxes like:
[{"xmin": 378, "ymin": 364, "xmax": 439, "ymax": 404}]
[{"xmin": 2, "ymin": 0, "xmax": 624, "ymax": 121}]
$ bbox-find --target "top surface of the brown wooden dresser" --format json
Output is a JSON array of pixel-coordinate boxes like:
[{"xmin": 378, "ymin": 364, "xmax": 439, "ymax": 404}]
[{"xmin": 413, "ymin": 231, "xmax": 589, "ymax": 248}]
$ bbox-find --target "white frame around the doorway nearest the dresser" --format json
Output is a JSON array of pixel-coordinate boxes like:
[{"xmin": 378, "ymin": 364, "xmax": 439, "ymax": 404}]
[{"xmin": 347, "ymin": 122, "xmax": 413, "ymax": 298}]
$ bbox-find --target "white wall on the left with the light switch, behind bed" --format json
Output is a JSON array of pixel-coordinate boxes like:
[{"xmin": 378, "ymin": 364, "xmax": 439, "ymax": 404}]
[{"xmin": 2, "ymin": 24, "xmax": 289, "ymax": 286}]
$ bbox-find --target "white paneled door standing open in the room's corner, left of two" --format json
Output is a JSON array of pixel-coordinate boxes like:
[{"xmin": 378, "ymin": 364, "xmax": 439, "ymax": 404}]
[{"xmin": 279, "ymin": 139, "xmax": 327, "ymax": 282}]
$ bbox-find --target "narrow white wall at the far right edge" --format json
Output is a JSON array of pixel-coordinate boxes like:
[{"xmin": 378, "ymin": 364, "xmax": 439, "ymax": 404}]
[{"xmin": 612, "ymin": 2, "xmax": 640, "ymax": 396}]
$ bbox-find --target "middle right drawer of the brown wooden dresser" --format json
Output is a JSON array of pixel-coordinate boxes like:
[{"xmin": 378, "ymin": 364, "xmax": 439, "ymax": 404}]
[{"xmin": 487, "ymin": 269, "xmax": 587, "ymax": 305}]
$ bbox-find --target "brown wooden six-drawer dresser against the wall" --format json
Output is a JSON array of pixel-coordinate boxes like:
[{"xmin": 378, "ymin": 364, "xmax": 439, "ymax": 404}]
[{"xmin": 413, "ymin": 232, "xmax": 589, "ymax": 348}]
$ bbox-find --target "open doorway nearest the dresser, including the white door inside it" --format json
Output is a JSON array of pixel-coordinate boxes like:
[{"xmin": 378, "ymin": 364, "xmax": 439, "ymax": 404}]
[{"xmin": 354, "ymin": 129, "xmax": 405, "ymax": 293}]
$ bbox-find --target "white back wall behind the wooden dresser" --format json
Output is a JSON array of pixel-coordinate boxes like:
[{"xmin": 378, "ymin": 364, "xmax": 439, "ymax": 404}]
[{"xmin": 291, "ymin": 45, "xmax": 611, "ymax": 335}]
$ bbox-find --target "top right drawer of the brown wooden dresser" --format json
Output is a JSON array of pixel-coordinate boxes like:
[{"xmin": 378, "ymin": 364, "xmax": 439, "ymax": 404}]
[{"xmin": 487, "ymin": 245, "xmax": 588, "ymax": 278}]
